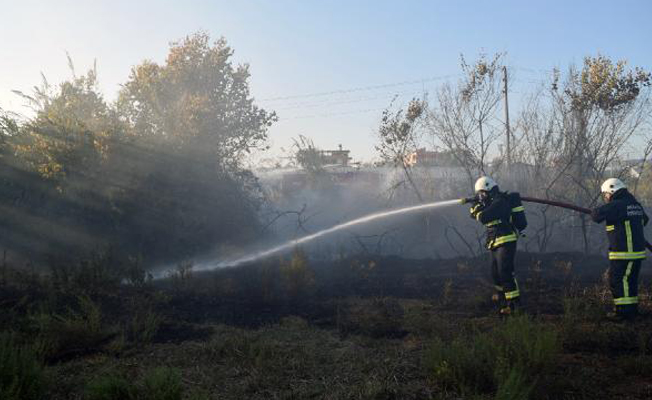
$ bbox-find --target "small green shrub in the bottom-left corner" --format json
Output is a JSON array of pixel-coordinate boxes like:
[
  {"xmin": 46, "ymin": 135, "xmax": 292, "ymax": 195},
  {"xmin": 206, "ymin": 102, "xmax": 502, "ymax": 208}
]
[{"xmin": 0, "ymin": 333, "xmax": 46, "ymax": 400}]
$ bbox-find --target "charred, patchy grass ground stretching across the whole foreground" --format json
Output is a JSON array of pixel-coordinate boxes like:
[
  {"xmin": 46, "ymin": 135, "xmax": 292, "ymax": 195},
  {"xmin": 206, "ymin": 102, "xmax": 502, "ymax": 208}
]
[{"xmin": 0, "ymin": 253, "xmax": 652, "ymax": 400}]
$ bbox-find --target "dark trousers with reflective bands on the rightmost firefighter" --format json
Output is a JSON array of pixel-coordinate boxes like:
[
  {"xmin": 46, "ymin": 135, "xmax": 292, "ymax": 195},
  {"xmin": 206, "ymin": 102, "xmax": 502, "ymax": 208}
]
[{"xmin": 609, "ymin": 260, "xmax": 642, "ymax": 316}]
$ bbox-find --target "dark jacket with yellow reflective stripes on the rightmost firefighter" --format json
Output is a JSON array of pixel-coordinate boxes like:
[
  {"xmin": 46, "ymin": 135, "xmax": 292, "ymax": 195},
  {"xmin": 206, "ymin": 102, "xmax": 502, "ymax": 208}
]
[{"xmin": 591, "ymin": 189, "xmax": 649, "ymax": 260}]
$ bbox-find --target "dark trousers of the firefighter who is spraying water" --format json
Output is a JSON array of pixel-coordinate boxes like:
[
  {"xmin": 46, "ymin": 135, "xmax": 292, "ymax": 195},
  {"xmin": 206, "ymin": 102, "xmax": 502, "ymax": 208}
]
[{"xmin": 491, "ymin": 242, "xmax": 521, "ymax": 309}]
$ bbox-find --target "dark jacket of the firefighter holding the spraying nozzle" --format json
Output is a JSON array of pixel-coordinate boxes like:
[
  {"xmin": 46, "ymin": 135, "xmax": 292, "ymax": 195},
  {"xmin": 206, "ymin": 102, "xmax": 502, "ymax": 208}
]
[{"xmin": 470, "ymin": 192, "xmax": 523, "ymax": 250}]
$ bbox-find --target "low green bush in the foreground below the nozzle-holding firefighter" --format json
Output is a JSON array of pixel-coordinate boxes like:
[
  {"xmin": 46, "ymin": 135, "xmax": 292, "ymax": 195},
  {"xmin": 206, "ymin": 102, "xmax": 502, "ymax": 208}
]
[{"xmin": 425, "ymin": 316, "xmax": 561, "ymax": 399}]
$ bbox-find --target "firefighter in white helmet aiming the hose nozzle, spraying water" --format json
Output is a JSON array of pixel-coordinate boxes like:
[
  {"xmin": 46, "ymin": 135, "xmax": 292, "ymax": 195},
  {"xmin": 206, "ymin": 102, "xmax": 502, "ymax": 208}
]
[{"xmin": 470, "ymin": 176, "xmax": 527, "ymax": 315}]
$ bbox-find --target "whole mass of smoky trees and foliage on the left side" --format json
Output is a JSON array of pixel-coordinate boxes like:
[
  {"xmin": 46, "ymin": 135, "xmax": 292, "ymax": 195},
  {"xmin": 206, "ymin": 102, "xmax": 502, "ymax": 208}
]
[{"xmin": 0, "ymin": 33, "xmax": 276, "ymax": 266}]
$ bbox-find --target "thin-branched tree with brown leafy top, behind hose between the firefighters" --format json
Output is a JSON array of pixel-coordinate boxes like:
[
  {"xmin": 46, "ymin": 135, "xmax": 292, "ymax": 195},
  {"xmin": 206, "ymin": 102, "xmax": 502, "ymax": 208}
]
[{"xmin": 552, "ymin": 55, "xmax": 652, "ymax": 251}]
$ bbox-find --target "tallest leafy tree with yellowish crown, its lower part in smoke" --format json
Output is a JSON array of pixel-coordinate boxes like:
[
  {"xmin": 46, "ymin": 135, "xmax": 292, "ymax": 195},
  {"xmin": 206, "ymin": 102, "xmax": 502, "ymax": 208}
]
[{"xmin": 109, "ymin": 33, "xmax": 276, "ymax": 258}]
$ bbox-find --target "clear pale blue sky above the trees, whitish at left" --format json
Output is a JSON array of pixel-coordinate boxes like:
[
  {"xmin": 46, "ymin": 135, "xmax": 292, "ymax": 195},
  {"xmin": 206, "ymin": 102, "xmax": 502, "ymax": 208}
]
[{"xmin": 0, "ymin": 0, "xmax": 652, "ymax": 161}]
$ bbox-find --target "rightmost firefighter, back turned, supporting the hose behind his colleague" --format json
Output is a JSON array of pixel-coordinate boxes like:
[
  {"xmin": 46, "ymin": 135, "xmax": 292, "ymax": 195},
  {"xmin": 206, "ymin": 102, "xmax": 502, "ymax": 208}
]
[{"xmin": 591, "ymin": 178, "xmax": 649, "ymax": 320}]
